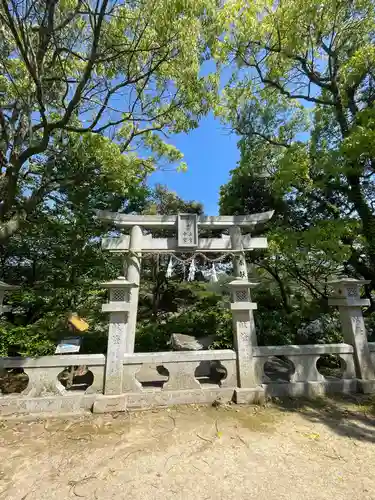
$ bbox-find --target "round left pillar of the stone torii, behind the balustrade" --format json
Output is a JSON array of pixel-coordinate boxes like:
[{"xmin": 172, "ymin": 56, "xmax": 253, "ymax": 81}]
[{"xmin": 125, "ymin": 226, "xmax": 143, "ymax": 354}]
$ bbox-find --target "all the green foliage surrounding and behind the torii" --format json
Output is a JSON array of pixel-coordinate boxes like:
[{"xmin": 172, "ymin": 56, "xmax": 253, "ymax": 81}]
[{"xmin": 0, "ymin": 0, "xmax": 375, "ymax": 355}]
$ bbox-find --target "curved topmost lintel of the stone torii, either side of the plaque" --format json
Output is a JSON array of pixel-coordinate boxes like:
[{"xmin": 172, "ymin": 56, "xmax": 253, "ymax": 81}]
[{"xmin": 97, "ymin": 210, "xmax": 274, "ymax": 229}]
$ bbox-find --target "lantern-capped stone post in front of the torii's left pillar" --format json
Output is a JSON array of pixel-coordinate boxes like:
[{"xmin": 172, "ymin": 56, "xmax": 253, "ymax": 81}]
[{"xmin": 102, "ymin": 276, "xmax": 137, "ymax": 394}]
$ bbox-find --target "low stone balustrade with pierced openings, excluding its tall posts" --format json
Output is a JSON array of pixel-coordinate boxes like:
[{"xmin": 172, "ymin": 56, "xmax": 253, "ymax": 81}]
[{"xmin": 0, "ymin": 343, "xmax": 375, "ymax": 413}]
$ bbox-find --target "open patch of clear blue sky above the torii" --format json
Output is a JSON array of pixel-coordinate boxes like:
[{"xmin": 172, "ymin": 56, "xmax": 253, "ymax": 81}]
[{"xmin": 150, "ymin": 114, "xmax": 239, "ymax": 215}]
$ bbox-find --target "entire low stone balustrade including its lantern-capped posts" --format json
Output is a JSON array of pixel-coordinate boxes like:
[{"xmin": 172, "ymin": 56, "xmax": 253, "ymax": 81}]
[{"xmin": 0, "ymin": 278, "xmax": 375, "ymax": 414}]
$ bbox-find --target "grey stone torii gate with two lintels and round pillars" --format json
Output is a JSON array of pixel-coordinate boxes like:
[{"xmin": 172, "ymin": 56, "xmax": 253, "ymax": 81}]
[{"xmin": 97, "ymin": 211, "xmax": 273, "ymax": 398}]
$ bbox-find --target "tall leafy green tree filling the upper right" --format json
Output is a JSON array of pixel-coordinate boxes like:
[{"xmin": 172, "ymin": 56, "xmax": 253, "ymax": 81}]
[{"xmin": 216, "ymin": 0, "xmax": 375, "ymax": 294}]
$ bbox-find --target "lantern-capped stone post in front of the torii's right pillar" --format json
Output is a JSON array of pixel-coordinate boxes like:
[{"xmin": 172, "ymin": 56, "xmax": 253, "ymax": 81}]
[{"xmin": 229, "ymin": 279, "xmax": 264, "ymax": 403}]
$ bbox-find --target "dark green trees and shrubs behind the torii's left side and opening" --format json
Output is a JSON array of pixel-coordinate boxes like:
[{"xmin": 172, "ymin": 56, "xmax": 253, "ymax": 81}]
[{"xmin": 1, "ymin": 158, "xmax": 228, "ymax": 356}]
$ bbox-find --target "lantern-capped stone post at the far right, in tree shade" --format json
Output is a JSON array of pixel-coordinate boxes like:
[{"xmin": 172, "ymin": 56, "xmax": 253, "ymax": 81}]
[{"xmin": 328, "ymin": 278, "xmax": 375, "ymax": 393}]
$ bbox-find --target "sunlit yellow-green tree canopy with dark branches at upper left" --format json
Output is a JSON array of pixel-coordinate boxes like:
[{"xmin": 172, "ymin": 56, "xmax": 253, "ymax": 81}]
[{"xmin": 0, "ymin": 0, "xmax": 219, "ymax": 242}]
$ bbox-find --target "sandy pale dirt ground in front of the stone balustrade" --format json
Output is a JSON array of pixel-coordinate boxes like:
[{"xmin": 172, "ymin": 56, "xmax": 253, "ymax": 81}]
[{"xmin": 0, "ymin": 400, "xmax": 375, "ymax": 500}]
